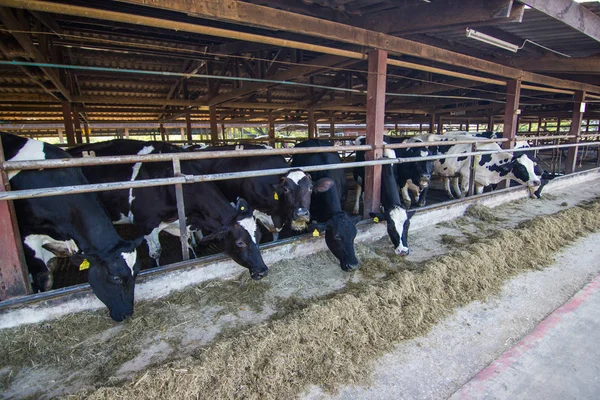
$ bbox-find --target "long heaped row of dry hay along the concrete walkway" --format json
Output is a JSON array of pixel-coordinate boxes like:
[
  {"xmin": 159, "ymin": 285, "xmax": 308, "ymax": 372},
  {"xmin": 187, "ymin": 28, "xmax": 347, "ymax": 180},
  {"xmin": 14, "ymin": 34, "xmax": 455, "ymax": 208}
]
[{"xmin": 69, "ymin": 202, "xmax": 600, "ymax": 399}]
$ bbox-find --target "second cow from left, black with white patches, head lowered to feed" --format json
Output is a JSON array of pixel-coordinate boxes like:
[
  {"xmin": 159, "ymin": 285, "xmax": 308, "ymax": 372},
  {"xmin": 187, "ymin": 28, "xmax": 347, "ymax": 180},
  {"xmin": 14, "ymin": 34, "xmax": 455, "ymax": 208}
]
[{"xmin": 69, "ymin": 139, "xmax": 268, "ymax": 279}]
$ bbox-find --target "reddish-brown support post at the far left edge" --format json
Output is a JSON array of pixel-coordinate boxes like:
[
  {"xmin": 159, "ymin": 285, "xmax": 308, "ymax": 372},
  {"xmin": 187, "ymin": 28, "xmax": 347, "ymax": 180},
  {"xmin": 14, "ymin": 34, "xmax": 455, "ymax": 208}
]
[{"xmin": 0, "ymin": 141, "xmax": 31, "ymax": 300}]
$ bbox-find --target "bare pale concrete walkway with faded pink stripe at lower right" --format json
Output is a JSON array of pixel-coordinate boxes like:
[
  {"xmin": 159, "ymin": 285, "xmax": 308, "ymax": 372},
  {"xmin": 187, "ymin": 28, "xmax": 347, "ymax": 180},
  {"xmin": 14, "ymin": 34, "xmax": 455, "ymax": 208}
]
[{"xmin": 303, "ymin": 233, "xmax": 600, "ymax": 400}]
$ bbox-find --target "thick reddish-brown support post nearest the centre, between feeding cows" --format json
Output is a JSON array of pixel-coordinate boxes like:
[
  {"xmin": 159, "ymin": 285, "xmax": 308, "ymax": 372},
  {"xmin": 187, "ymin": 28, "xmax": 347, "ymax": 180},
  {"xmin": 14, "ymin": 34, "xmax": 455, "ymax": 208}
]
[{"xmin": 363, "ymin": 50, "xmax": 387, "ymax": 222}]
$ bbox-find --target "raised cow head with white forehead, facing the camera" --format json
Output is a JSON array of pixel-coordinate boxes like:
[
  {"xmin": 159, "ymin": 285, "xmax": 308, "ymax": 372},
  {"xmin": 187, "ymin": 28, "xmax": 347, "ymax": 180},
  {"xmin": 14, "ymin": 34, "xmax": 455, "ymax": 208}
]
[{"xmin": 273, "ymin": 169, "xmax": 313, "ymax": 231}]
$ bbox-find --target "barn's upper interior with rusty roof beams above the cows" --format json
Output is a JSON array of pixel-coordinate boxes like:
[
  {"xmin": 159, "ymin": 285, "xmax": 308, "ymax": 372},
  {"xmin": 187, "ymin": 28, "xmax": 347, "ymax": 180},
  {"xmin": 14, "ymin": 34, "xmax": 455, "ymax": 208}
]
[{"xmin": 0, "ymin": 0, "xmax": 600, "ymax": 296}]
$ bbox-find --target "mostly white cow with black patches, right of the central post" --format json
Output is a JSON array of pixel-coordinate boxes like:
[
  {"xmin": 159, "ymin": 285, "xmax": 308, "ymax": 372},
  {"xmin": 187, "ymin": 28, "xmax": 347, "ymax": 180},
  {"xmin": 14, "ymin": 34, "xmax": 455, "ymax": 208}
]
[{"xmin": 419, "ymin": 134, "xmax": 541, "ymax": 198}]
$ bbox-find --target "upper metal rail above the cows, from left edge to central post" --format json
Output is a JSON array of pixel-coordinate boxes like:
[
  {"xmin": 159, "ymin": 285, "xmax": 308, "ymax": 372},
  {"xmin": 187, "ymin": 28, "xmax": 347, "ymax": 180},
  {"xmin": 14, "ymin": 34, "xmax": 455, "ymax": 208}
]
[{"xmin": 1, "ymin": 145, "xmax": 371, "ymax": 171}]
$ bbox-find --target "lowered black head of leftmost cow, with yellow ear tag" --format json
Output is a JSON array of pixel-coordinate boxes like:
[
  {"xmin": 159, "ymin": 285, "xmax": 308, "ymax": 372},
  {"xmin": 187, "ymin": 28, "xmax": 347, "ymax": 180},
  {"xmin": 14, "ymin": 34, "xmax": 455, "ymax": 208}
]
[{"xmin": 43, "ymin": 237, "xmax": 143, "ymax": 321}]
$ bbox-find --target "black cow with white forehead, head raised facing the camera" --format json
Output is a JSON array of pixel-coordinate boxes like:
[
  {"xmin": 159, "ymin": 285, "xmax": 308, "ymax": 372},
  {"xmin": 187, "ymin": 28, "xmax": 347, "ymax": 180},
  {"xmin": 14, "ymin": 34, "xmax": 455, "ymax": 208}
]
[{"xmin": 188, "ymin": 145, "xmax": 313, "ymax": 239}]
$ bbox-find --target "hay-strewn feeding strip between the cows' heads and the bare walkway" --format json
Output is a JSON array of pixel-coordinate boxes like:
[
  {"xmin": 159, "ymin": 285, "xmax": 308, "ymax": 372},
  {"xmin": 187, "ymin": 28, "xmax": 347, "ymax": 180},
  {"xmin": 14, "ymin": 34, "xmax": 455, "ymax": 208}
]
[{"xmin": 0, "ymin": 183, "xmax": 600, "ymax": 399}]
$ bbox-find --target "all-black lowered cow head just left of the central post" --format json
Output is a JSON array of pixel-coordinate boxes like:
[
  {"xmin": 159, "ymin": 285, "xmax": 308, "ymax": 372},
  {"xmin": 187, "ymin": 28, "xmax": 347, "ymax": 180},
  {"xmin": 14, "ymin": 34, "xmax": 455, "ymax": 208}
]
[{"xmin": 311, "ymin": 178, "xmax": 360, "ymax": 271}]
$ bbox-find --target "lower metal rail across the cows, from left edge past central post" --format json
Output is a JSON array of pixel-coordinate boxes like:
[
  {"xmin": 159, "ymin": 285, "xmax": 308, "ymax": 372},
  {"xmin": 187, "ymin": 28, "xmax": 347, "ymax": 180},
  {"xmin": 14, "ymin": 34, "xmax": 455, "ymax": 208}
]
[{"xmin": 0, "ymin": 158, "xmax": 398, "ymax": 200}]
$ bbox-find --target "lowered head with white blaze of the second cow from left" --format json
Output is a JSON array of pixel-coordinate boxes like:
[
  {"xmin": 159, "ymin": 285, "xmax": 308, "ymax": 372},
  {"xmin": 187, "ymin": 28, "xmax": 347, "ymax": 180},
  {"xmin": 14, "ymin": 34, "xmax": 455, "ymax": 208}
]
[{"xmin": 209, "ymin": 199, "xmax": 269, "ymax": 280}]
